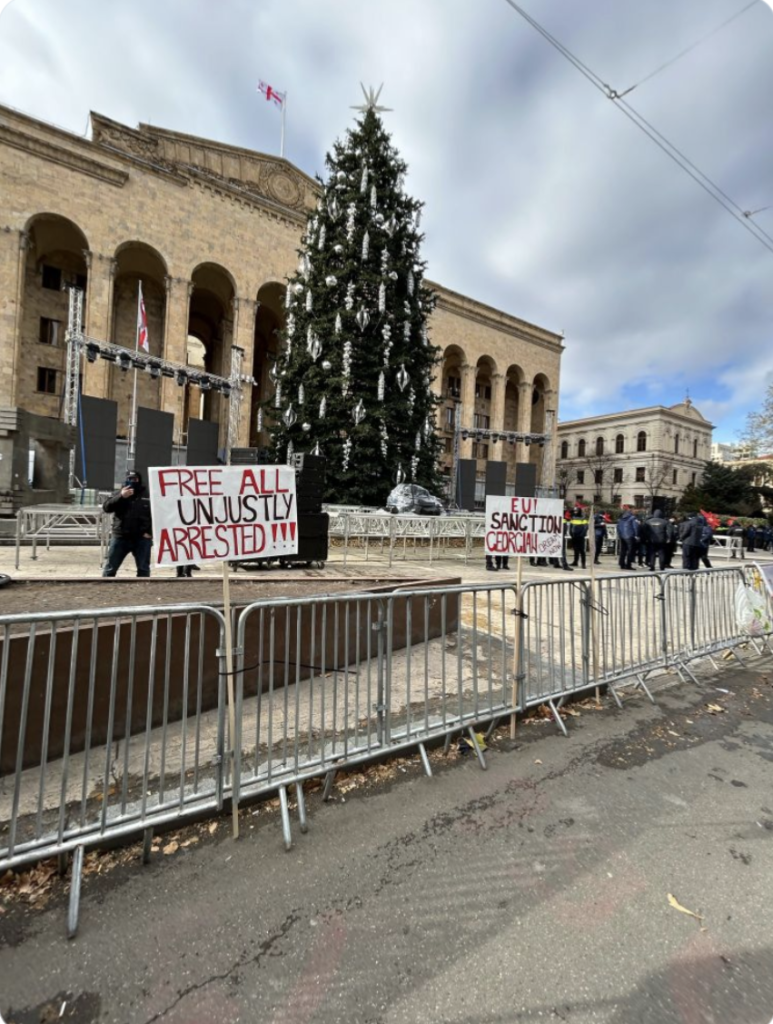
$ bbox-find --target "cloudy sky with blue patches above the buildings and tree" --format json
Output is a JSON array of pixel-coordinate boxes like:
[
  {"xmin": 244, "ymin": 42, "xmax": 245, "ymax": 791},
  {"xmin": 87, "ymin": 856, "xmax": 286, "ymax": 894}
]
[{"xmin": 0, "ymin": 0, "xmax": 773, "ymax": 440}]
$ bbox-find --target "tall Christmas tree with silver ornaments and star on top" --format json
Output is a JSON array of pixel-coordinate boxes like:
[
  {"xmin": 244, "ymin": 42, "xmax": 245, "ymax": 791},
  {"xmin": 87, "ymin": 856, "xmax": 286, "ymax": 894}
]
[{"xmin": 266, "ymin": 90, "xmax": 440, "ymax": 505}]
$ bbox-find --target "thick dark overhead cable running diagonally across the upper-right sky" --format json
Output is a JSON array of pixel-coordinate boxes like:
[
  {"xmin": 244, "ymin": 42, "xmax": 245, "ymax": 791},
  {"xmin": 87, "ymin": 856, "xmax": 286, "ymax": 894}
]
[{"xmin": 505, "ymin": 0, "xmax": 773, "ymax": 253}]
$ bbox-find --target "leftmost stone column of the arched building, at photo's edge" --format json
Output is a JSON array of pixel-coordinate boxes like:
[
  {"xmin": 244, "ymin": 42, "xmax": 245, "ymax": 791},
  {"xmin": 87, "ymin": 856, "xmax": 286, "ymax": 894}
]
[{"xmin": 0, "ymin": 227, "xmax": 30, "ymax": 407}]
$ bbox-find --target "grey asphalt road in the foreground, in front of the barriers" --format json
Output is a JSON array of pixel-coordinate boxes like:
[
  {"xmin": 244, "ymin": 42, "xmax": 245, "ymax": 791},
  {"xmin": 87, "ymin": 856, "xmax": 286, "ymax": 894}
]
[{"xmin": 0, "ymin": 659, "xmax": 773, "ymax": 1024}]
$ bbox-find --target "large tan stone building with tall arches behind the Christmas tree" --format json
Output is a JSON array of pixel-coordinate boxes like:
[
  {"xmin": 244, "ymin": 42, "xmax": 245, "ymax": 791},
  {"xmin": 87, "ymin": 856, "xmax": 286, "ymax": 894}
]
[{"xmin": 0, "ymin": 106, "xmax": 563, "ymax": 504}]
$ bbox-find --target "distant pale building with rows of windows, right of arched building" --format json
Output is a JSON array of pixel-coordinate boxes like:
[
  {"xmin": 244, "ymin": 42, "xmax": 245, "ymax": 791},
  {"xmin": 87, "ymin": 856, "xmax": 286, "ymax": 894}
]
[{"xmin": 556, "ymin": 398, "xmax": 714, "ymax": 509}]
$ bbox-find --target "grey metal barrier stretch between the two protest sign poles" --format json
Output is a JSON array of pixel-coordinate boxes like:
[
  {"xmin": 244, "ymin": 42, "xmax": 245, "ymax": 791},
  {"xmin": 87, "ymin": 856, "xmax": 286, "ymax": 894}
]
[{"xmin": 233, "ymin": 586, "xmax": 515, "ymax": 823}]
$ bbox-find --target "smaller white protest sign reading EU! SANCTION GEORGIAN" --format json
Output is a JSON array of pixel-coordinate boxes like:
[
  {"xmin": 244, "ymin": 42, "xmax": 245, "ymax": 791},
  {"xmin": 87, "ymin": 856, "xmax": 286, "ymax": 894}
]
[{"xmin": 485, "ymin": 496, "xmax": 564, "ymax": 558}]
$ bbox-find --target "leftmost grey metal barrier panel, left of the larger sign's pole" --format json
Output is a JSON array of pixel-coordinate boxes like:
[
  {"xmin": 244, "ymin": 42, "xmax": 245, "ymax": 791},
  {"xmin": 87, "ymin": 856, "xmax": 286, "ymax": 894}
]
[{"xmin": 0, "ymin": 605, "xmax": 224, "ymax": 871}]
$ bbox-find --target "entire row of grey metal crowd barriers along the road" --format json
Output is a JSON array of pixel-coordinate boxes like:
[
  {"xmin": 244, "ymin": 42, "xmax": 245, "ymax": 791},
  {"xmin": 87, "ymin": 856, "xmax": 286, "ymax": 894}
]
[{"xmin": 0, "ymin": 566, "xmax": 770, "ymax": 934}]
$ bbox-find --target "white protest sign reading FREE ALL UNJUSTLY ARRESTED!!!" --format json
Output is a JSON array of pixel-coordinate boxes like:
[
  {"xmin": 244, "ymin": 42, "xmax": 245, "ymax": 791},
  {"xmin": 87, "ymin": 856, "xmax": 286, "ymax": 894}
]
[{"xmin": 147, "ymin": 466, "xmax": 298, "ymax": 566}]
